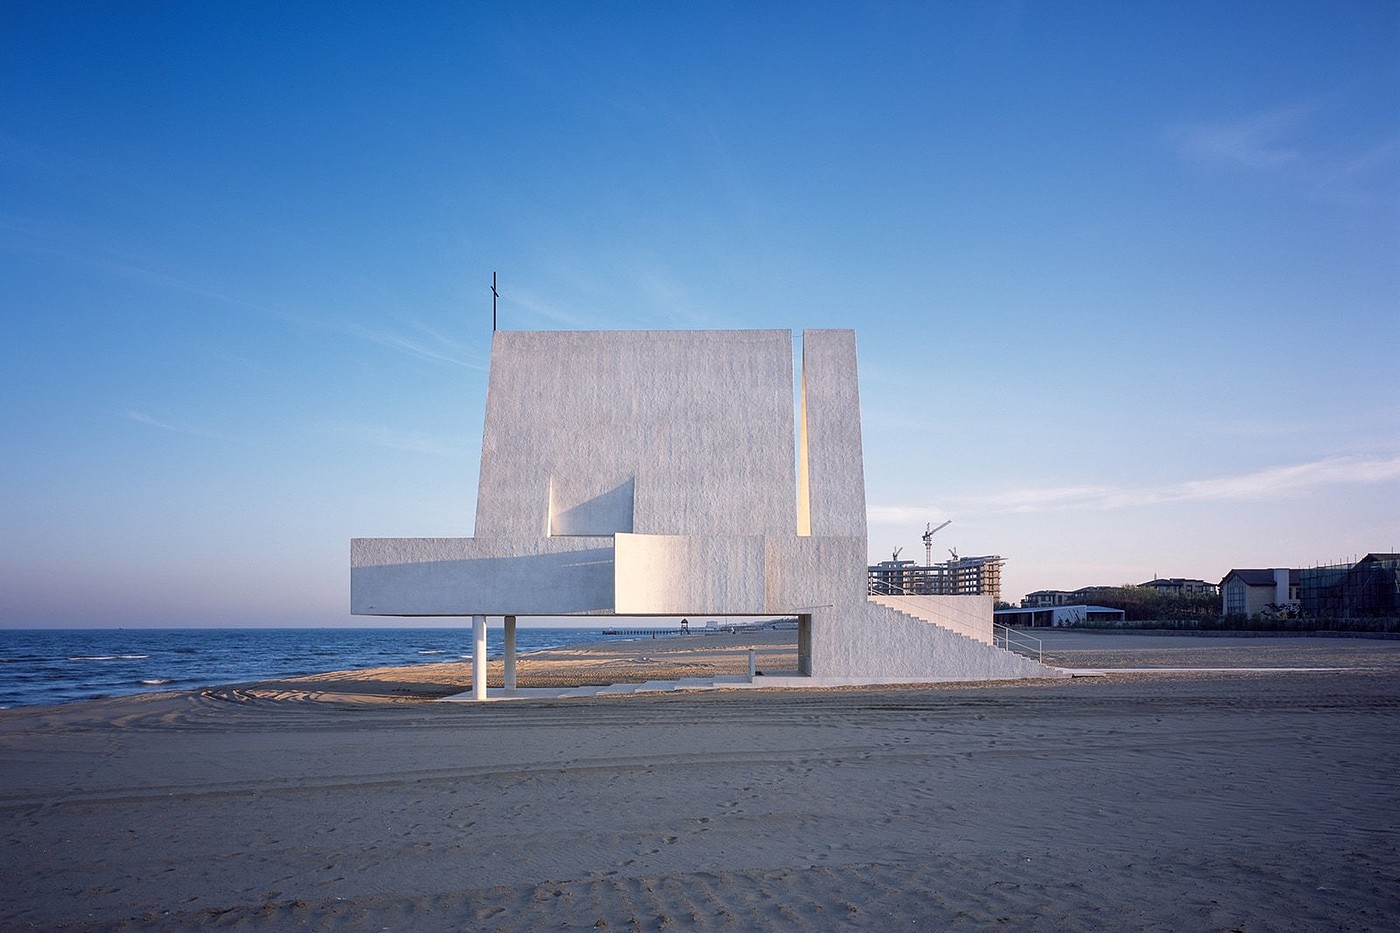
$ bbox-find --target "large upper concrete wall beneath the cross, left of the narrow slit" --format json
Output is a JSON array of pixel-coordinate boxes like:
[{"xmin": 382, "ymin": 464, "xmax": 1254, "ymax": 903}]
[{"xmin": 475, "ymin": 331, "xmax": 797, "ymax": 538}]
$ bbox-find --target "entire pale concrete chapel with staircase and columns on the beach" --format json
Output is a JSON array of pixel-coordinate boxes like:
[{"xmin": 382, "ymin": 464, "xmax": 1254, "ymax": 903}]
[{"xmin": 350, "ymin": 323, "xmax": 1058, "ymax": 696}]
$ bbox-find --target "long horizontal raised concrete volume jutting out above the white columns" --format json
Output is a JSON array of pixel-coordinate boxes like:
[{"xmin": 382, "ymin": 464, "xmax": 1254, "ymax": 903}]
[{"xmin": 350, "ymin": 534, "xmax": 865, "ymax": 615}]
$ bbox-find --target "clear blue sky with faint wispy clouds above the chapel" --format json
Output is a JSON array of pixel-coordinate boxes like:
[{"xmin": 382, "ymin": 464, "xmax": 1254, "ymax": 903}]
[{"xmin": 0, "ymin": 1, "xmax": 1400, "ymax": 626}]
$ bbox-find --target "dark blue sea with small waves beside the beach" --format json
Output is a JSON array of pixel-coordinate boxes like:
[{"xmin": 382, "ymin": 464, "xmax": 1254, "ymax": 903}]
[{"xmin": 0, "ymin": 626, "xmax": 655, "ymax": 709}]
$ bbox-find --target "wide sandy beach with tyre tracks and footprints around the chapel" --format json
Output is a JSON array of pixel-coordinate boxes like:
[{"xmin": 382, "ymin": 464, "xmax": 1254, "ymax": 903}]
[{"xmin": 0, "ymin": 633, "xmax": 1400, "ymax": 930}]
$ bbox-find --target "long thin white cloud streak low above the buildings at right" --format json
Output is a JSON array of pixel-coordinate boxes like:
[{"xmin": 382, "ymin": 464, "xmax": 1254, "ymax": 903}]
[{"xmin": 869, "ymin": 457, "xmax": 1400, "ymax": 524}]
